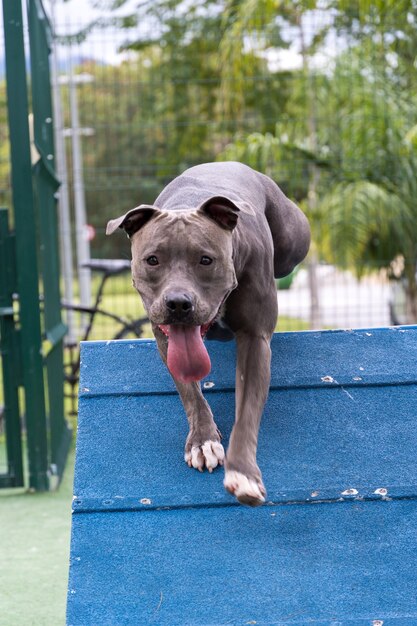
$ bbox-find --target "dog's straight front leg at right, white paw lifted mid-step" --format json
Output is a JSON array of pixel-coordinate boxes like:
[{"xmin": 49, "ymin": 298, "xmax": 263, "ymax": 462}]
[{"xmin": 224, "ymin": 332, "xmax": 271, "ymax": 506}]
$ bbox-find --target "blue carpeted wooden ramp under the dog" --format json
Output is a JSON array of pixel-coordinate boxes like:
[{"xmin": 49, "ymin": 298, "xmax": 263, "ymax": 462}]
[{"xmin": 67, "ymin": 327, "xmax": 417, "ymax": 626}]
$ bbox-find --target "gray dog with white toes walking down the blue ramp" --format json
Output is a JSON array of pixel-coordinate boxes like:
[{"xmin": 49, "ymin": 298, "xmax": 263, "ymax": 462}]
[{"xmin": 106, "ymin": 162, "xmax": 310, "ymax": 506}]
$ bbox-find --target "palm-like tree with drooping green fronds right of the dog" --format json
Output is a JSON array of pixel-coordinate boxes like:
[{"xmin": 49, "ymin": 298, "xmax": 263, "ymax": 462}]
[{"xmin": 216, "ymin": 0, "xmax": 417, "ymax": 321}]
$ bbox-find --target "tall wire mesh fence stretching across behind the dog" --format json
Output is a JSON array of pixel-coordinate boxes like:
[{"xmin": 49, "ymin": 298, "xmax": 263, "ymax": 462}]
[{"xmin": 0, "ymin": 0, "xmax": 417, "ymax": 338}]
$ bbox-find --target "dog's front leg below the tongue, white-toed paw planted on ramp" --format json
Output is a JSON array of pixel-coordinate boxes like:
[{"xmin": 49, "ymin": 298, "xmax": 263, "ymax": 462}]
[{"xmin": 153, "ymin": 326, "xmax": 224, "ymax": 472}]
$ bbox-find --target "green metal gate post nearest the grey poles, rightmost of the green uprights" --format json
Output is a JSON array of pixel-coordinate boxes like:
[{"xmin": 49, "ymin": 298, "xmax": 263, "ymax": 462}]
[{"xmin": 28, "ymin": 0, "xmax": 71, "ymax": 477}]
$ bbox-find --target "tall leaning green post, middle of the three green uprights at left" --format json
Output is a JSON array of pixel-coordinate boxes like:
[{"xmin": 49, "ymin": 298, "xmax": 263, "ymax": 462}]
[{"xmin": 3, "ymin": 0, "xmax": 49, "ymax": 490}]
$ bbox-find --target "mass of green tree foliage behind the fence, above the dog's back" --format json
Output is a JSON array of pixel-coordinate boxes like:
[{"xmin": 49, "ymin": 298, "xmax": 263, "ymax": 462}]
[{"xmin": 0, "ymin": 0, "xmax": 417, "ymax": 304}]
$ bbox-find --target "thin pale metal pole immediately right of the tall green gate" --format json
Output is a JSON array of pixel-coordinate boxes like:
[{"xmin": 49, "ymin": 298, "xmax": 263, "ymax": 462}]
[{"xmin": 50, "ymin": 0, "xmax": 75, "ymax": 343}]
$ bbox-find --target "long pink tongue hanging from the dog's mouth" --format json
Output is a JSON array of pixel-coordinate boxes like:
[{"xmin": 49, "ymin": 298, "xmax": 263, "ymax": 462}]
[{"xmin": 168, "ymin": 324, "xmax": 211, "ymax": 383}]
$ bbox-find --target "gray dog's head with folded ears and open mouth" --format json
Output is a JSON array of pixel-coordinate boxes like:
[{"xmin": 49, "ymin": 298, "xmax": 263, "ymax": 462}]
[{"xmin": 106, "ymin": 196, "xmax": 245, "ymax": 380}]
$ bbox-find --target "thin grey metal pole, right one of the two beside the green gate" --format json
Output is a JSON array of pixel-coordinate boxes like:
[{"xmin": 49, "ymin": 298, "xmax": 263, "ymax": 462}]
[{"xmin": 68, "ymin": 53, "xmax": 91, "ymax": 306}]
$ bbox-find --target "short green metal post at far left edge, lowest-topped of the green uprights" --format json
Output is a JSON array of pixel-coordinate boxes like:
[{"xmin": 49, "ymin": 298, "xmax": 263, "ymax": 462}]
[{"xmin": 0, "ymin": 208, "xmax": 24, "ymax": 487}]
